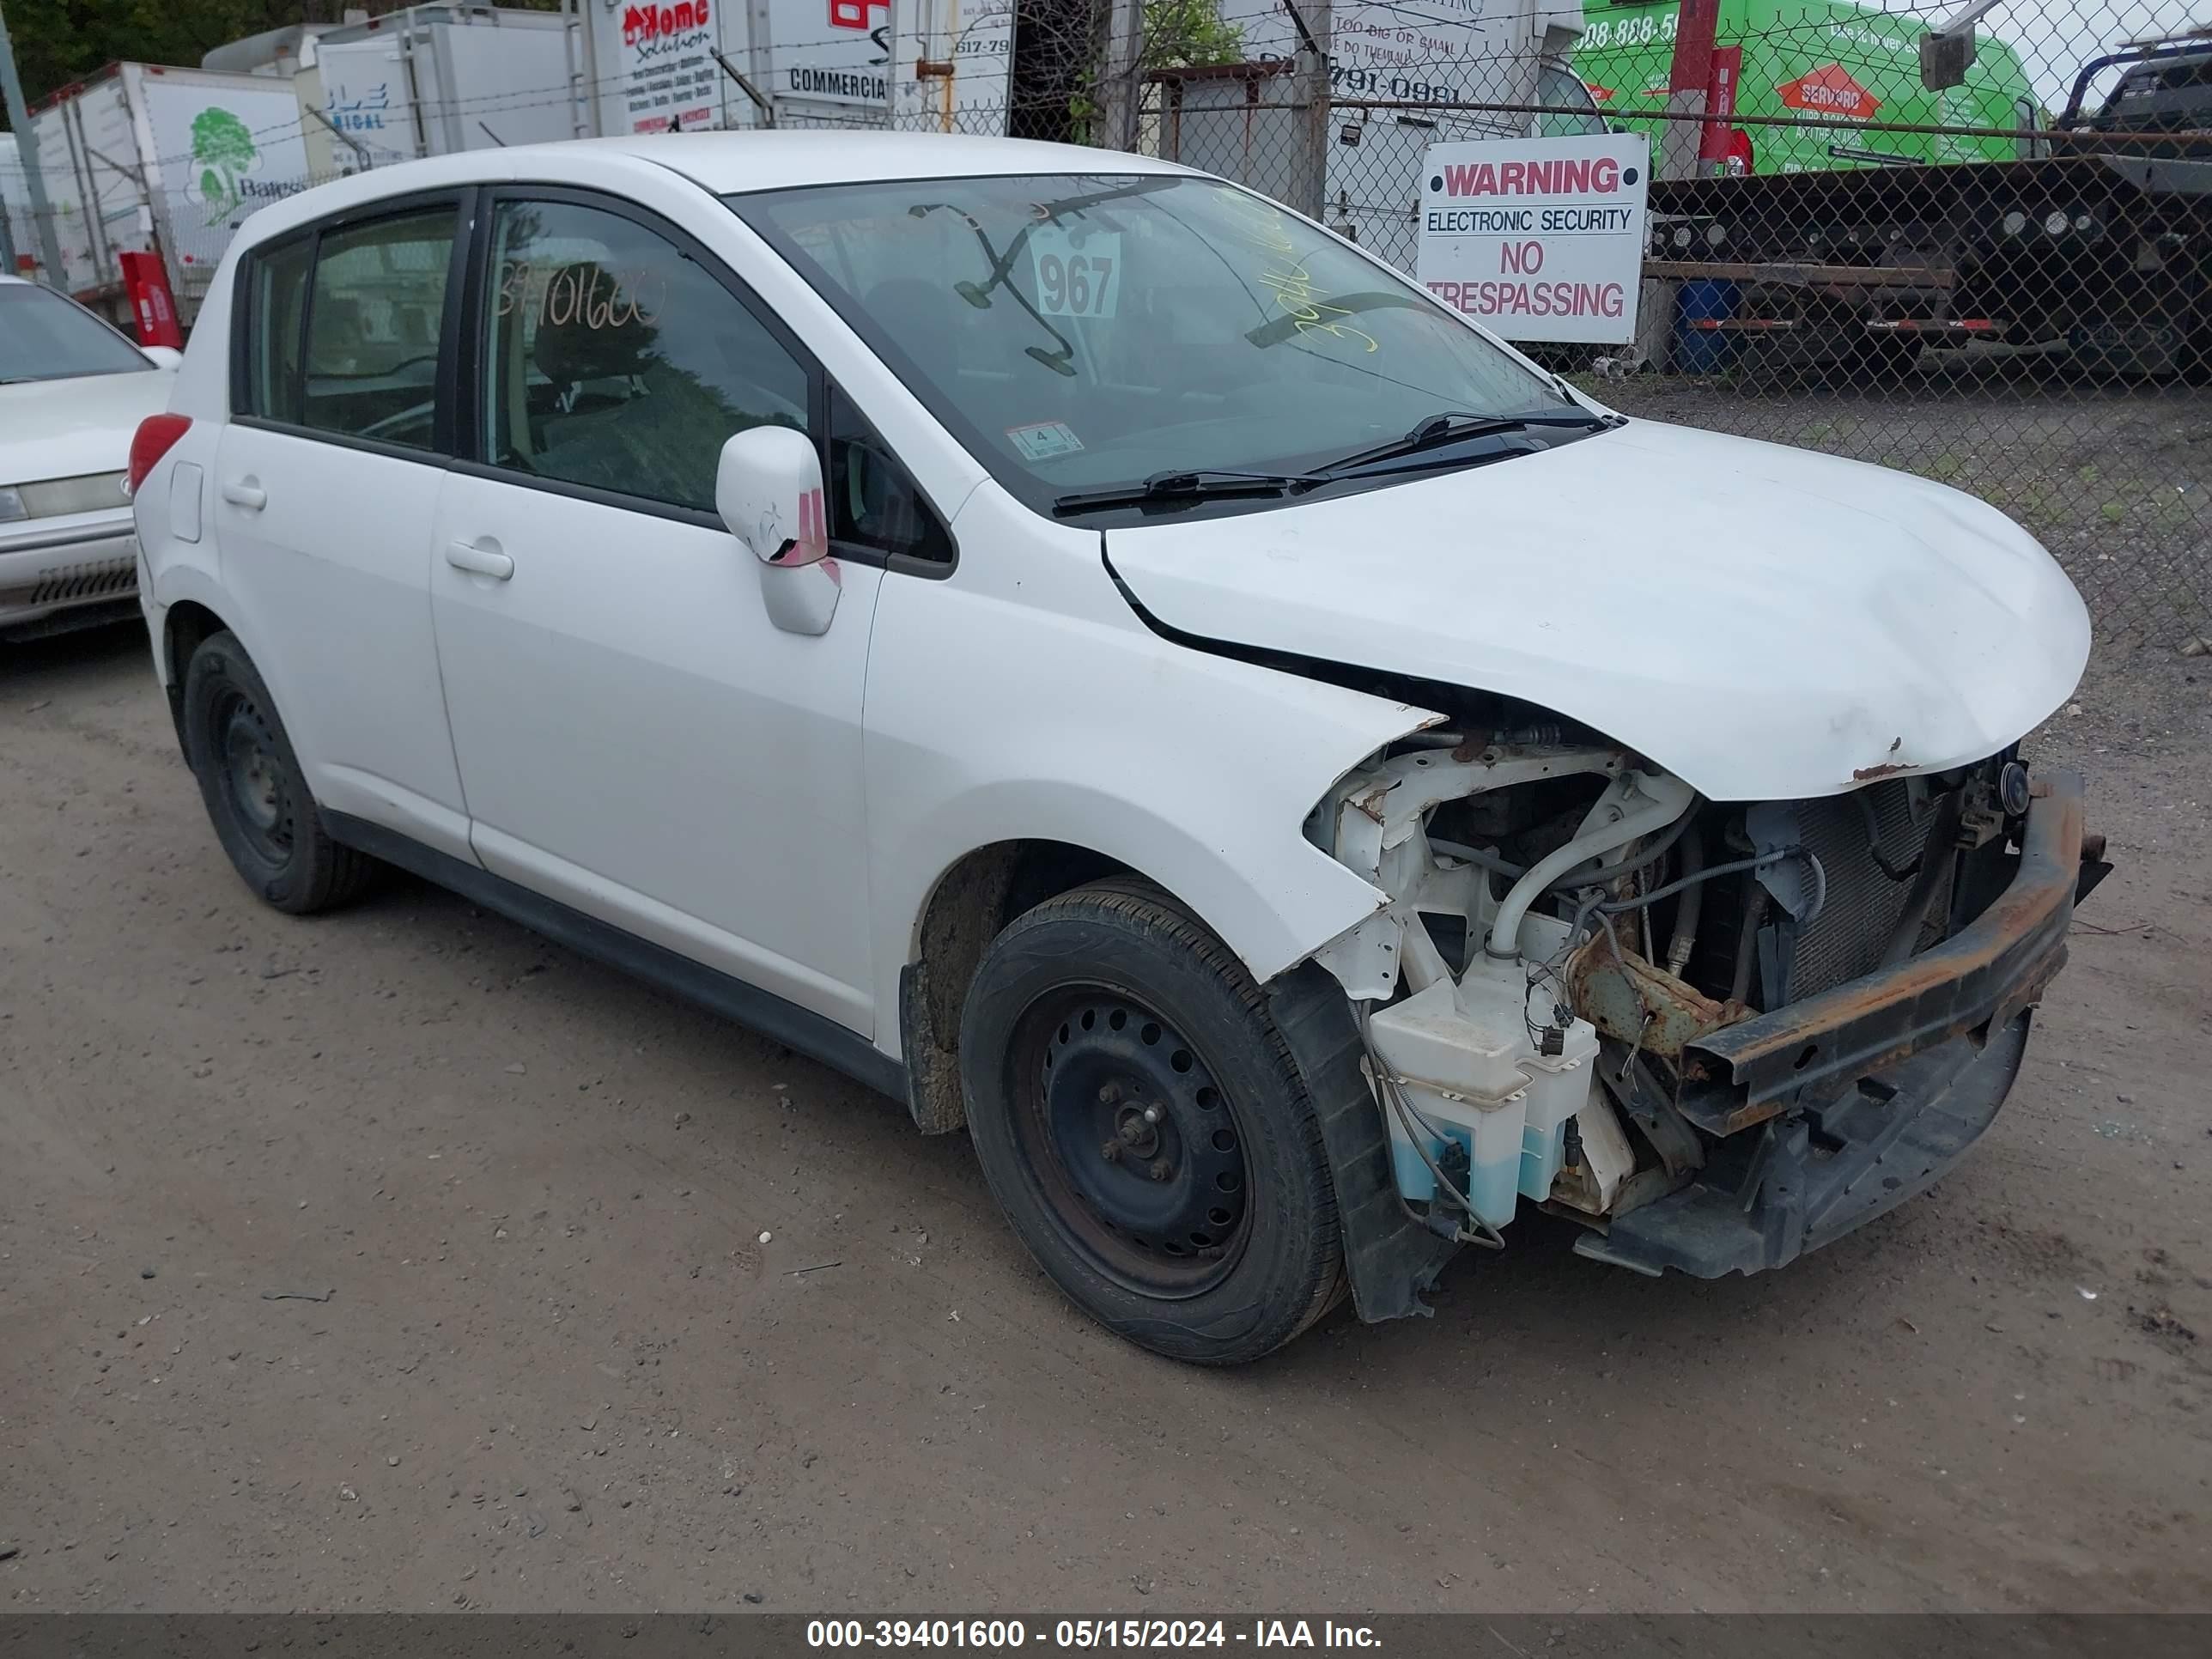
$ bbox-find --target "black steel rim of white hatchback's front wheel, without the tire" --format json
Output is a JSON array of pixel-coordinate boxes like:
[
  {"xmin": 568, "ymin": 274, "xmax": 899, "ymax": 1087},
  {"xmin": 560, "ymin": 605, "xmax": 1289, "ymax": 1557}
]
[{"xmin": 1011, "ymin": 984, "xmax": 1252, "ymax": 1298}]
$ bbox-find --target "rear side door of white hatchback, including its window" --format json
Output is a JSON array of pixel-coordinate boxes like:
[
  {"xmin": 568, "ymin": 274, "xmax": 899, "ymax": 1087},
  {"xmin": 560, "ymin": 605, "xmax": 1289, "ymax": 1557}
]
[{"xmin": 212, "ymin": 192, "xmax": 473, "ymax": 858}]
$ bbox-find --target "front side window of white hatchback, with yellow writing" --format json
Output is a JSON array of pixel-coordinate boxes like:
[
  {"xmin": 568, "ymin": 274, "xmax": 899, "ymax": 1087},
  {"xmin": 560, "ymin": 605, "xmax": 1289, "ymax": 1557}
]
[{"xmin": 483, "ymin": 201, "xmax": 807, "ymax": 511}]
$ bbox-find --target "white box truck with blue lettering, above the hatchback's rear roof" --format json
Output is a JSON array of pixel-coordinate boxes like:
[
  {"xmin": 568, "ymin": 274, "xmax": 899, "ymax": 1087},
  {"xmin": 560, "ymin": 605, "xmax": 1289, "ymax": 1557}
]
[{"xmin": 292, "ymin": 7, "xmax": 591, "ymax": 175}]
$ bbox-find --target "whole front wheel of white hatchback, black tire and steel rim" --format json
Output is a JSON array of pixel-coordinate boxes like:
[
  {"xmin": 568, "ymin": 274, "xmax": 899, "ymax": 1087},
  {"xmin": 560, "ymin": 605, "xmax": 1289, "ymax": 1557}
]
[{"xmin": 960, "ymin": 883, "xmax": 1345, "ymax": 1364}]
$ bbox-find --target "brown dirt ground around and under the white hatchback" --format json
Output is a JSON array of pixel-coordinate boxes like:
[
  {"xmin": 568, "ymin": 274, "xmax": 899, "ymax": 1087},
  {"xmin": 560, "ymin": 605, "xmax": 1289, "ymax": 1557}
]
[{"xmin": 0, "ymin": 630, "xmax": 2212, "ymax": 1614}]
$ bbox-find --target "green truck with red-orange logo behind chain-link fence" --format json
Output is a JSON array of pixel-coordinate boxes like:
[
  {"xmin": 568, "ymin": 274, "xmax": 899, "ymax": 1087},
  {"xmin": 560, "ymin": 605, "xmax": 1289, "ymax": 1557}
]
[{"xmin": 1575, "ymin": 0, "xmax": 2044, "ymax": 173}]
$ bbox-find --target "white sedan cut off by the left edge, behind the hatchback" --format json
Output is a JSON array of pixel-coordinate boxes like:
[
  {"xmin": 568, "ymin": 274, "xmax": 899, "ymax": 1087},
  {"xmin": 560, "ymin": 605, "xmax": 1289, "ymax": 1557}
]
[{"xmin": 0, "ymin": 276, "xmax": 181, "ymax": 637}]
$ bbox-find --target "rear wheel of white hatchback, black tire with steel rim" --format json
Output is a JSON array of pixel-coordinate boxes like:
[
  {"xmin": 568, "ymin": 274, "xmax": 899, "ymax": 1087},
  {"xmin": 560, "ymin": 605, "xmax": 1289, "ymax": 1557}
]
[{"xmin": 184, "ymin": 633, "xmax": 376, "ymax": 915}]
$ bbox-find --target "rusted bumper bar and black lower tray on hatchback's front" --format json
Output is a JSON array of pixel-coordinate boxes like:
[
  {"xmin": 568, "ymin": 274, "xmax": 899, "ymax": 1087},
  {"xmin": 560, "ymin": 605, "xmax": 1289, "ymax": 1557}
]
[{"xmin": 1575, "ymin": 772, "xmax": 2104, "ymax": 1279}]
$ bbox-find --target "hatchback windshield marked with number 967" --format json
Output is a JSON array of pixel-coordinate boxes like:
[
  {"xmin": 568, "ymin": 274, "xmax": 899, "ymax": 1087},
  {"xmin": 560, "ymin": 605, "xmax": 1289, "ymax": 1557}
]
[{"xmin": 730, "ymin": 173, "xmax": 1575, "ymax": 507}]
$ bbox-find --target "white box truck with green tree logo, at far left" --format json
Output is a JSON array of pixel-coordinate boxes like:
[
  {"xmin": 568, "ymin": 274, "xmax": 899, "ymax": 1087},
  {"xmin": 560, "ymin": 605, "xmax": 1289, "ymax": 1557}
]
[{"xmin": 9, "ymin": 64, "xmax": 310, "ymax": 325}]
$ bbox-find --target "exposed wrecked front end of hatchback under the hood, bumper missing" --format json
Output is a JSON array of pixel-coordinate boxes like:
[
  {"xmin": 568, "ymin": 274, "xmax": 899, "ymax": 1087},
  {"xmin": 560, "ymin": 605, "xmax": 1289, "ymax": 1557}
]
[{"xmin": 1307, "ymin": 723, "xmax": 2108, "ymax": 1310}]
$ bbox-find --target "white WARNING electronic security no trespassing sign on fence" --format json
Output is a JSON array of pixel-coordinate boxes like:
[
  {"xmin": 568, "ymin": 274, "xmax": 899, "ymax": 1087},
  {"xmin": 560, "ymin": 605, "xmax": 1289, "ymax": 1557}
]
[{"xmin": 1420, "ymin": 133, "xmax": 1650, "ymax": 345}]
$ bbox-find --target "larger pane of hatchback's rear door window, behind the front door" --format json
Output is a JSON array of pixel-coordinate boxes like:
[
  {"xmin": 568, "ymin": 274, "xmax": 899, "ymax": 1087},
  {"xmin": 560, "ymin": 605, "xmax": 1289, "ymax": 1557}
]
[{"xmin": 299, "ymin": 208, "xmax": 456, "ymax": 449}]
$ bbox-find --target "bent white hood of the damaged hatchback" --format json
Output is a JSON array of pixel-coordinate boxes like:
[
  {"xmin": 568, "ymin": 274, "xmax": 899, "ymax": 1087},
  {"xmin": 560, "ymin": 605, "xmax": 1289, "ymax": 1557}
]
[{"xmin": 1106, "ymin": 420, "xmax": 2088, "ymax": 801}]
